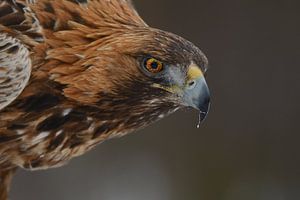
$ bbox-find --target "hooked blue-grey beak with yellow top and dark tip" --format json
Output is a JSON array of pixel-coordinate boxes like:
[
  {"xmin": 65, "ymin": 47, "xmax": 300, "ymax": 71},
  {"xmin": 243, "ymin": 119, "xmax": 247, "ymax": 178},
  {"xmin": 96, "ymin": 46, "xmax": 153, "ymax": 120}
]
[{"xmin": 183, "ymin": 64, "xmax": 210, "ymax": 122}]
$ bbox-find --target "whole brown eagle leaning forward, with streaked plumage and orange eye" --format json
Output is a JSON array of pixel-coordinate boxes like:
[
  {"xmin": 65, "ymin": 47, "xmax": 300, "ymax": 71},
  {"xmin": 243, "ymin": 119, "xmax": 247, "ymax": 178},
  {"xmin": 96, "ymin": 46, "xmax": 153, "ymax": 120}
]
[{"xmin": 0, "ymin": 0, "xmax": 210, "ymax": 200}]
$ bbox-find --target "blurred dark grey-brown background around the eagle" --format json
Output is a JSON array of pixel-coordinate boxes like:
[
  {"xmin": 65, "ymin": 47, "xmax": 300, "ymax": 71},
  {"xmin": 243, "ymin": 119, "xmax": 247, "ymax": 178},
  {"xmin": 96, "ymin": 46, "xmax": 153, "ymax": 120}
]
[{"xmin": 11, "ymin": 0, "xmax": 300, "ymax": 200}]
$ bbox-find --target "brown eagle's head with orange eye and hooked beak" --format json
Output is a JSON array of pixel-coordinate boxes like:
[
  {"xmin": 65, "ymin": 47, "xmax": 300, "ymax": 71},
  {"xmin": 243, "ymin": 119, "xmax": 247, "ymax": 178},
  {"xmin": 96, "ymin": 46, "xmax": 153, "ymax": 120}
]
[{"xmin": 60, "ymin": 27, "xmax": 210, "ymax": 133}]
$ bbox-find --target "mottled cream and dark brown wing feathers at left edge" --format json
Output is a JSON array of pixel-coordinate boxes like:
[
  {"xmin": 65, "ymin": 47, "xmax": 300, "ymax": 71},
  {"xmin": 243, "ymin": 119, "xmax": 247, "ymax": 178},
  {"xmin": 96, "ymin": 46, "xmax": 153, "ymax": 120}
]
[{"xmin": 0, "ymin": 0, "xmax": 43, "ymax": 110}]
